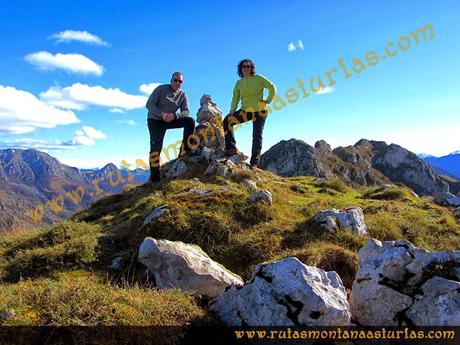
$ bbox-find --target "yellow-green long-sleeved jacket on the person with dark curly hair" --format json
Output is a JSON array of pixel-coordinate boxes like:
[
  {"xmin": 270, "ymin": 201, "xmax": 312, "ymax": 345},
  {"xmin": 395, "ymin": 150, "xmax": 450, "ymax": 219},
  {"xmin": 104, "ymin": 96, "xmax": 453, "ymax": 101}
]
[{"xmin": 230, "ymin": 74, "xmax": 276, "ymax": 113}]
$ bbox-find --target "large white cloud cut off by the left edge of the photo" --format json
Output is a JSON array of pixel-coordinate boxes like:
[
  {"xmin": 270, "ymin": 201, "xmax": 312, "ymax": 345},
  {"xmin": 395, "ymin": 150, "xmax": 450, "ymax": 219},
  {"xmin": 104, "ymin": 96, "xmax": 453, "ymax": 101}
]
[{"xmin": 0, "ymin": 85, "xmax": 80, "ymax": 135}]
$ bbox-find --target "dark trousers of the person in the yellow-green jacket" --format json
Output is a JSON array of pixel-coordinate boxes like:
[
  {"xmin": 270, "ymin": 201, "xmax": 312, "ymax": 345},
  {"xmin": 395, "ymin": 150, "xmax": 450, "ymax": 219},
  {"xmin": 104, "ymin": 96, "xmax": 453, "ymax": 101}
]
[{"xmin": 224, "ymin": 109, "xmax": 267, "ymax": 165}]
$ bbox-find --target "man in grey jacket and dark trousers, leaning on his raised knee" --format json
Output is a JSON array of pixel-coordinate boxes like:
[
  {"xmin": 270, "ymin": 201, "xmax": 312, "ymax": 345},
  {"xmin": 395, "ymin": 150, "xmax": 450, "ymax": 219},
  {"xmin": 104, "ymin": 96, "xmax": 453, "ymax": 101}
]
[{"xmin": 146, "ymin": 72, "xmax": 195, "ymax": 182}]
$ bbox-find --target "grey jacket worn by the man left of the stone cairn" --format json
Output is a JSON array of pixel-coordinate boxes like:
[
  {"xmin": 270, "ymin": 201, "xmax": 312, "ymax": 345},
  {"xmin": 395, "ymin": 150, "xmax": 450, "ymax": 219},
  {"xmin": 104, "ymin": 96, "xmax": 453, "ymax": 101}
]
[{"xmin": 145, "ymin": 84, "xmax": 189, "ymax": 120}]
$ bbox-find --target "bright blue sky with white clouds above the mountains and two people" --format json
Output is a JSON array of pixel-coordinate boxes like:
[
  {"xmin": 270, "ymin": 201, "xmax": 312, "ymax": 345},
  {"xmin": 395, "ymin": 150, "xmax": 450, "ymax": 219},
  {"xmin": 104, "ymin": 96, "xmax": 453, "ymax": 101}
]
[{"xmin": 0, "ymin": 1, "xmax": 460, "ymax": 167}]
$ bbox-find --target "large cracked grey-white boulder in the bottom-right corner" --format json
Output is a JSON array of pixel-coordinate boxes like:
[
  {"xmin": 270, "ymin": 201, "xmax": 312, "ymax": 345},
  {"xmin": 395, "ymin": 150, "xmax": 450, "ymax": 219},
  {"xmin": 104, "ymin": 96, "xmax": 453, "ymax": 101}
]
[{"xmin": 350, "ymin": 239, "xmax": 460, "ymax": 326}]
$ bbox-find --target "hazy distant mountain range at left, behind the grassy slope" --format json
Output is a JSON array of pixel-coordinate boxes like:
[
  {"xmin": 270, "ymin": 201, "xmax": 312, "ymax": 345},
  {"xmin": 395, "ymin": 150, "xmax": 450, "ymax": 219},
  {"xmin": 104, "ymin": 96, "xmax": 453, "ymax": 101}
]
[{"xmin": 0, "ymin": 149, "xmax": 149, "ymax": 231}]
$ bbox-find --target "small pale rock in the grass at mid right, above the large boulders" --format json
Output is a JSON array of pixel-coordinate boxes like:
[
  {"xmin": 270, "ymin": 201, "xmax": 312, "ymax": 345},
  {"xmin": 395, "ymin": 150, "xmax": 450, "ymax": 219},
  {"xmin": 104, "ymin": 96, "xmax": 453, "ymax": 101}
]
[{"xmin": 313, "ymin": 206, "xmax": 367, "ymax": 236}]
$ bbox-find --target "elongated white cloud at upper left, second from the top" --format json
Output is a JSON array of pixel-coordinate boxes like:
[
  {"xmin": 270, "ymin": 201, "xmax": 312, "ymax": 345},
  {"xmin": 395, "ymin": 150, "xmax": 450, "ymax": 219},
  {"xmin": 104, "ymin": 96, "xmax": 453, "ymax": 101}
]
[{"xmin": 25, "ymin": 51, "xmax": 104, "ymax": 76}]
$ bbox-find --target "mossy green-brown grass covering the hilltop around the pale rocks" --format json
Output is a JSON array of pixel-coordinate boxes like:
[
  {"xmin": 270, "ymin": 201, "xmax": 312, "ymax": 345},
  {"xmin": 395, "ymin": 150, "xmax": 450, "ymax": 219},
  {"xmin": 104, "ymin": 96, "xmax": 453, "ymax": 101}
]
[{"xmin": 0, "ymin": 162, "xmax": 460, "ymax": 325}]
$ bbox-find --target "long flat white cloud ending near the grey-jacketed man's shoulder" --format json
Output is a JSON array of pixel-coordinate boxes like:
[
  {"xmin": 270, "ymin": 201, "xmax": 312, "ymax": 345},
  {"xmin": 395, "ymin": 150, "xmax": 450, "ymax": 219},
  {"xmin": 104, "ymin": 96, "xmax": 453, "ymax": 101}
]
[{"xmin": 40, "ymin": 83, "xmax": 147, "ymax": 112}]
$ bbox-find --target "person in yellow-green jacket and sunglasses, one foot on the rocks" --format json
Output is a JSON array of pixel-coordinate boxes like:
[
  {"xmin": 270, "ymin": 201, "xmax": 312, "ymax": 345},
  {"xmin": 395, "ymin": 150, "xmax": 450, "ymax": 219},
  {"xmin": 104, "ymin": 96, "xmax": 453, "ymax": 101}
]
[{"xmin": 223, "ymin": 59, "xmax": 276, "ymax": 170}]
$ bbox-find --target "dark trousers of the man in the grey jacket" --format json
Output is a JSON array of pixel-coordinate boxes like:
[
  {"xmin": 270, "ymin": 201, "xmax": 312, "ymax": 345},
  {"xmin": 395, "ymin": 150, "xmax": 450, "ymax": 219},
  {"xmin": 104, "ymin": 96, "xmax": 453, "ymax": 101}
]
[{"xmin": 147, "ymin": 117, "xmax": 196, "ymax": 181}]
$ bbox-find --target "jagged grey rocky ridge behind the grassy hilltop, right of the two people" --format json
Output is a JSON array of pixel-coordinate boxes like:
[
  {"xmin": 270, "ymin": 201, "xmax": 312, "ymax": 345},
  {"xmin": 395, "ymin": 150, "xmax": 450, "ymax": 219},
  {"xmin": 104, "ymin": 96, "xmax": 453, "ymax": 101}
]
[{"xmin": 260, "ymin": 139, "xmax": 449, "ymax": 195}]
